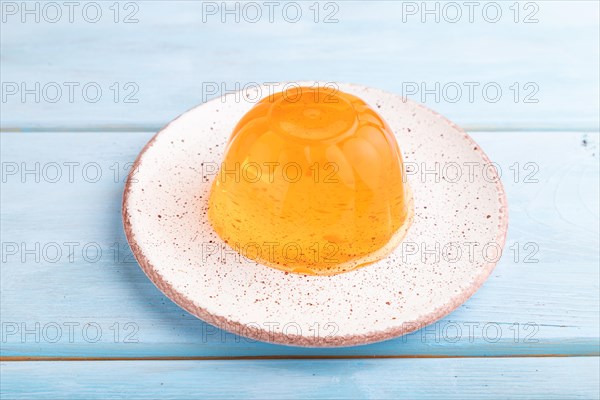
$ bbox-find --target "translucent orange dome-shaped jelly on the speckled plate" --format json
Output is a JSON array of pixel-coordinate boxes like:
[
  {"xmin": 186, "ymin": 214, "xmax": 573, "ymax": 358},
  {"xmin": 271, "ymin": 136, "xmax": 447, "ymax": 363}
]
[{"xmin": 209, "ymin": 87, "xmax": 412, "ymax": 275}]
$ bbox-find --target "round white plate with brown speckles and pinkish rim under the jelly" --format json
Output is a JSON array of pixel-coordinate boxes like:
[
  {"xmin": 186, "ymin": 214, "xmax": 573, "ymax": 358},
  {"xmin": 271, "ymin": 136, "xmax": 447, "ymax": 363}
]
[{"xmin": 123, "ymin": 82, "xmax": 508, "ymax": 347}]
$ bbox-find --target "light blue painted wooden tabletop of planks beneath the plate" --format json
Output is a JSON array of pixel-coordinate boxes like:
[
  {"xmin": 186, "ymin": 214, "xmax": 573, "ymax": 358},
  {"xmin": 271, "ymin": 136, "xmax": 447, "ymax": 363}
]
[{"xmin": 0, "ymin": 1, "xmax": 600, "ymax": 399}]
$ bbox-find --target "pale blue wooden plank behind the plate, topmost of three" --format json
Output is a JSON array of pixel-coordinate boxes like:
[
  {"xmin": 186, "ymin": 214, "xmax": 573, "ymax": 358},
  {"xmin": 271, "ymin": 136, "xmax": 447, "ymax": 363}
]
[{"xmin": 0, "ymin": 1, "xmax": 599, "ymax": 130}]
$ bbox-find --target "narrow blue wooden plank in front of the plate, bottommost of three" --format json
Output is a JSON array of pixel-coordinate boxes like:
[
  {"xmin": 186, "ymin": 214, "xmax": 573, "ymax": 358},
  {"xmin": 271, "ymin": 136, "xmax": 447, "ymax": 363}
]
[{"xmin": 1, "ymin": 357, "xmax": 600, "ymax": 400}]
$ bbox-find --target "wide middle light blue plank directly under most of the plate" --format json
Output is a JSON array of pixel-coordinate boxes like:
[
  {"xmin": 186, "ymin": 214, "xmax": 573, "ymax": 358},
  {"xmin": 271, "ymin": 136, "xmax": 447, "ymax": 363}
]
[{"xmin": 0, "ymin": 132, "xmax": 599, "ymax": 357}]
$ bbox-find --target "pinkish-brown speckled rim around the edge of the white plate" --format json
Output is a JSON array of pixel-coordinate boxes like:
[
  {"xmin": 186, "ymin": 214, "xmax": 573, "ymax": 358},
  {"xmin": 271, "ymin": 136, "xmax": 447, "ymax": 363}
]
[{"xmin": 121, "ymin": 84, "xmax": 508, "ymax": 347}]
